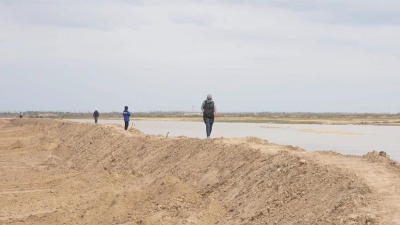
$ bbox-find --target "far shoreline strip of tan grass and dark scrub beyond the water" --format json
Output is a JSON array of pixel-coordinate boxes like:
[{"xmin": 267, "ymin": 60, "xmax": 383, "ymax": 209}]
[{"xmin": 0, "ymin": 111, "xmax": 400, "ymax": 126}]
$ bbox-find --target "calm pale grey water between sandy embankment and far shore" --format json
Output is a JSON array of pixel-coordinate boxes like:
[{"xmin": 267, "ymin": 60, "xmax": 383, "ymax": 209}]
[{"xmin": 69, "ymin": 119, "xmax": 400, "ymax": 161}]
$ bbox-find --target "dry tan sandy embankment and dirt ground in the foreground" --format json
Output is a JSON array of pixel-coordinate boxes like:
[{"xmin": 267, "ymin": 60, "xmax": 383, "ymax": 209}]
[{"xmin": 0, "ymin": 119, "xmax": 400, "ymax": 225}]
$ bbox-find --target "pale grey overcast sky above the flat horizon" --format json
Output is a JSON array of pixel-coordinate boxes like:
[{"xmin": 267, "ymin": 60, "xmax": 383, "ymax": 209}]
[{"xmin": 0, "ymin": 0, "xmax": 400, "ymax": 113}]
